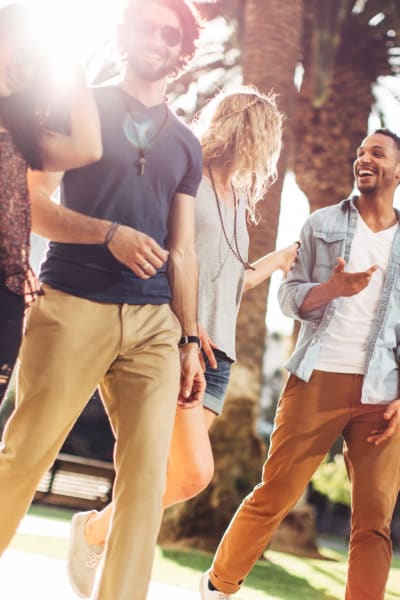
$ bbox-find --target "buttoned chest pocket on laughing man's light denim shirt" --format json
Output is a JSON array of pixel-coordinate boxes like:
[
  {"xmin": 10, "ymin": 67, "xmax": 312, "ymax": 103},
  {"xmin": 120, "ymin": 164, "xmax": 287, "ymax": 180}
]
[{"xmin": 312, "ymin": 231, "xmax": 346, "ymax": 283}]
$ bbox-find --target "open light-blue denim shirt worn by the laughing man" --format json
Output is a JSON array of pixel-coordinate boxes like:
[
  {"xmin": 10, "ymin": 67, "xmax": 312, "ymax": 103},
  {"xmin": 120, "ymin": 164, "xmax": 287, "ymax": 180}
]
[{"xmin": 278, "ymin": 198, "xmax": 400, "ymax": 404}]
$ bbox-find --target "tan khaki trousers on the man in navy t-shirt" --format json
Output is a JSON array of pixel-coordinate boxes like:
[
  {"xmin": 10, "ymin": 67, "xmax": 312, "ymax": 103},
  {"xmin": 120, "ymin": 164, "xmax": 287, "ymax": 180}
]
[{"xmin": 0, "ymin": 286, "xmax": 180, "ymax": 600}]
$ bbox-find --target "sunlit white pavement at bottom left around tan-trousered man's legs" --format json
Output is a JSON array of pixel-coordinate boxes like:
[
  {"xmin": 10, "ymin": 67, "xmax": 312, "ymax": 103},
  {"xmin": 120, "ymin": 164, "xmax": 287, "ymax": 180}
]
[{"xmin": 0, "ymin": 515, "xmax": 199, "ymax": 600}]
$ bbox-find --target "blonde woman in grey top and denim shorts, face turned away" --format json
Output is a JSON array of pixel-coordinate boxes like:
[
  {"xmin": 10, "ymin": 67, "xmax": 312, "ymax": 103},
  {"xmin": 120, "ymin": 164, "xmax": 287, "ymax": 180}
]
[{"xmin": 68, "ymin": 86, "xmax": 298, "ymax": 597}]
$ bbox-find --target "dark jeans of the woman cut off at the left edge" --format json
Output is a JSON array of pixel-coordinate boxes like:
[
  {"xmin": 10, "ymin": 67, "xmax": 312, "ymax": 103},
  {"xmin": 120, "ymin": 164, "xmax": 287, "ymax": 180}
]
[{"xmin": 0, "ymin": 272, "xmax": 25, "ymax": 404}]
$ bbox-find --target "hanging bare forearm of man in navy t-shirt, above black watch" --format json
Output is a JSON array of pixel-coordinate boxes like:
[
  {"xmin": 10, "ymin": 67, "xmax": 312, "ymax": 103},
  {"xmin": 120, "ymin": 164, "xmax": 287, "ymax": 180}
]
[{"xmin": 167, "ymin": 250, "xmax": 198, "ymax": 335}]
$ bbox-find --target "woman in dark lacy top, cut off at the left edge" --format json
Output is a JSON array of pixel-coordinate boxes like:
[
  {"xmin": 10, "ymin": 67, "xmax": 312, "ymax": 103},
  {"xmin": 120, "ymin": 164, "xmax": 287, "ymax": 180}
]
[{"xmin": 0, "ymin": 4, "xmax": 101, "ymax": 403}]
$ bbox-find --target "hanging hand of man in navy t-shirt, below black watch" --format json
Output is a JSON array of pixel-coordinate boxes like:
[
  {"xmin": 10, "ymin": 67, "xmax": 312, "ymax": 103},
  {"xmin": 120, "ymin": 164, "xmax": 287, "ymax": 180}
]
[{"xmin": 178, "ymin": 344, "xmax": 206, "ymax": 408}]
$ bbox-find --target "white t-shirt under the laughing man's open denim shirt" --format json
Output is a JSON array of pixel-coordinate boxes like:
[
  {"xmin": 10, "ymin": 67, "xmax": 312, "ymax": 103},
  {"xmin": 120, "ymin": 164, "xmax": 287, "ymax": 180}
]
[{"xmin": 315, "ymin": 215, "xmax": 398, "ymax": 375}]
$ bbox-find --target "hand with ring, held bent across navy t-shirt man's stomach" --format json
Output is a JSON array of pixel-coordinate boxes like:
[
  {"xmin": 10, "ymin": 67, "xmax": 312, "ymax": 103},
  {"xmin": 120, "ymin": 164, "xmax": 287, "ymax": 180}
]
[{"xmin": 108, "ymin": 225, "xmax": 168, "ymax": 279}]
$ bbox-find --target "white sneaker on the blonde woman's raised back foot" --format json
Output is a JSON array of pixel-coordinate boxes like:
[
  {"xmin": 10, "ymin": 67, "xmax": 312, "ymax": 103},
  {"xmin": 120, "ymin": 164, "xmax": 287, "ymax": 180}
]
[{"xmin": 67, "ymin": 511, "xmax": 104, "ymax": 598}]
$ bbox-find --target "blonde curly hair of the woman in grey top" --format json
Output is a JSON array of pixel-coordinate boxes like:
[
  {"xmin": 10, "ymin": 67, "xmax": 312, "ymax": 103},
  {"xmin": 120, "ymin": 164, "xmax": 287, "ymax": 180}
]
[{"xmin": 194, "ymin": 85, "xmax": 283, "ymax": 222}]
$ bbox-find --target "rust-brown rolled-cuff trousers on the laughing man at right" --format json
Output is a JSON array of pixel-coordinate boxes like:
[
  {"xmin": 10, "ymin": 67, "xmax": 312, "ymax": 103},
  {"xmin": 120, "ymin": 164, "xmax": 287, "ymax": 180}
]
[{"xmin": 210, "ymin": 371, "xmax": 400, "ymax": 600}]
